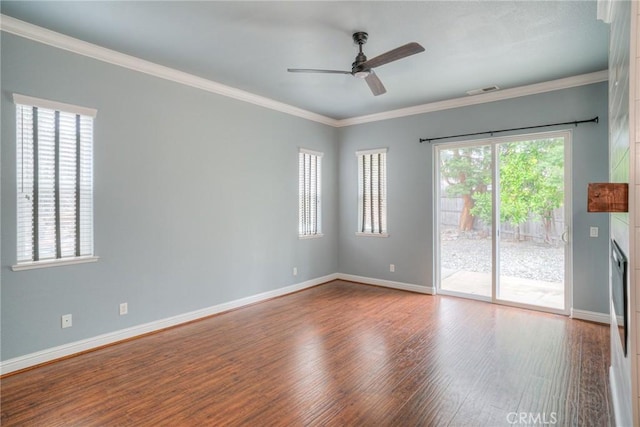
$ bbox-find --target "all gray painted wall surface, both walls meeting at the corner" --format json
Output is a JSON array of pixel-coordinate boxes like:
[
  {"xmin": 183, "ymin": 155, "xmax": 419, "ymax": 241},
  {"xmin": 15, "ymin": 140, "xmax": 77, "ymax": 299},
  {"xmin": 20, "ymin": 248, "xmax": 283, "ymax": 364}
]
[{"xmin": 0, "ymin": 33, "xmax": 608, "ymax": 360}]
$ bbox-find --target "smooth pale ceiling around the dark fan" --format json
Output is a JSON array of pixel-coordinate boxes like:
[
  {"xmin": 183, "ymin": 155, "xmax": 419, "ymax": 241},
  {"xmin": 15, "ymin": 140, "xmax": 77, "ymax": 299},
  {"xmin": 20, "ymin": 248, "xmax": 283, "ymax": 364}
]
[{"xmin": 0, "ymin": 0, "xmax": 609, "ymax": 119}]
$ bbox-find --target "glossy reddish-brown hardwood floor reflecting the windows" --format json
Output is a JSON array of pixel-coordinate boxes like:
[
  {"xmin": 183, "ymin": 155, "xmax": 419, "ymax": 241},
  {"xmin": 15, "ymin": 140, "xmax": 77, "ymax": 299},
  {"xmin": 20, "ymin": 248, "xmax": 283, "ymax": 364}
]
[{"xmin": 0, "ymin": 281, "xmax": 612, "ymax": 426}]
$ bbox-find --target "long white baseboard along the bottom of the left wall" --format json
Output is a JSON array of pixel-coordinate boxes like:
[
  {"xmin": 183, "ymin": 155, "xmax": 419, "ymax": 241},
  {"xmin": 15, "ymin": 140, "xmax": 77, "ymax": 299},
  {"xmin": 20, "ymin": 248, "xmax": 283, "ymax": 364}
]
[{"xmin": 0, "ymin": 273, "xmax": 338, "ymax": 375}]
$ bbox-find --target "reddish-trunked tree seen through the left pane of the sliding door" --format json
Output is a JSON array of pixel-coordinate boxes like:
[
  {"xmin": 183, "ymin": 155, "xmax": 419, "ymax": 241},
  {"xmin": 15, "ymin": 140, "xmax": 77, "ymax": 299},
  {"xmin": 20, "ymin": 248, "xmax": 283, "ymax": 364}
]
[{"xmin": 440, "ymin": 145, "xmax": 491, "ymax": 231}]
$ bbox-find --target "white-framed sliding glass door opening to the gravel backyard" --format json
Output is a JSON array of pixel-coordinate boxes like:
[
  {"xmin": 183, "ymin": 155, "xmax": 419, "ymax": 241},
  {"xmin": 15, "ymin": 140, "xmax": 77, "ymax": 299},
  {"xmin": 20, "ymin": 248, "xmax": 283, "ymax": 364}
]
[{"xmin": 434, "ymin": 132, "xmax": 571, "ymax": 313}]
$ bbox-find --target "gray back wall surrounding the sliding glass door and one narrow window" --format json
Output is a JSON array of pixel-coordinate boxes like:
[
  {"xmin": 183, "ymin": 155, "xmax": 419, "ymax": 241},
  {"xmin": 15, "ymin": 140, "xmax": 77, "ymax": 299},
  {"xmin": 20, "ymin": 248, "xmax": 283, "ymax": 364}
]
[{"xmin": 339, "ymin": 83, "xmax": 609, "ymax": 313}]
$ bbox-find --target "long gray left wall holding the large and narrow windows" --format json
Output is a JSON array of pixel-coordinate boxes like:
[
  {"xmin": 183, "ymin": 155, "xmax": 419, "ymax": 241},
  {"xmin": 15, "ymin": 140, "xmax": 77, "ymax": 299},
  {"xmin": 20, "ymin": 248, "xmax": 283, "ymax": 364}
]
[{"xmin": 1, "ymin": 33, "xmax": 338, "ymax": 360}]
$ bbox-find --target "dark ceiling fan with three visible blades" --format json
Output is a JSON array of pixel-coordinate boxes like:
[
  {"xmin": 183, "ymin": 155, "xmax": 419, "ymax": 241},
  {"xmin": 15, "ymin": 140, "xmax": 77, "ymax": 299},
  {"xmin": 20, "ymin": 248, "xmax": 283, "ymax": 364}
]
[{"xmin": 287, "ymin": 31, "xmax": 424, "ymax": 96}]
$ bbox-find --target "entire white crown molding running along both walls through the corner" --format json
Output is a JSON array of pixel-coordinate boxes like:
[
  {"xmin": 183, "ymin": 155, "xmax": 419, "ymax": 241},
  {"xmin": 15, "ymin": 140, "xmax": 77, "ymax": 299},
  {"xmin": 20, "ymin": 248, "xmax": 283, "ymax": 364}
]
[{"xmin": 0, "ymin": 14, "xmax": 608, "ymax": 128}]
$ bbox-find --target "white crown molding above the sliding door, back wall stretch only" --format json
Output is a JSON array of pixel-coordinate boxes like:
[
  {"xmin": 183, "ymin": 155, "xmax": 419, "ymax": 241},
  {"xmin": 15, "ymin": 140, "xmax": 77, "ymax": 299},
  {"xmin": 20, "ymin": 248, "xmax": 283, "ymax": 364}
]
[{"xmin": 336, "ymin": 70, "xmax": 609, "ymax": 127}]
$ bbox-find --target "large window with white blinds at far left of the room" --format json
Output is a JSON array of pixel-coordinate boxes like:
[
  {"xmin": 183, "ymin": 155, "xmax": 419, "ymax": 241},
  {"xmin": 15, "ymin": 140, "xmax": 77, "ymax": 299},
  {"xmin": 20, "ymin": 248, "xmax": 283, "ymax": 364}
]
[{"xmin": 14, "ymin": 94, "xmax": 96, "ymax": 270}]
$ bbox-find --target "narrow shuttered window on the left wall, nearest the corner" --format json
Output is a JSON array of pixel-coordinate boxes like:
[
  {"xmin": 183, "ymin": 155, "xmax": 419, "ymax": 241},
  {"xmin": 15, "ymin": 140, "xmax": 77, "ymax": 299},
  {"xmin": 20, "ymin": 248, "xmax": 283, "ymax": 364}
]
[{"xmin": 298, "ymin": 148, "xmax": 322, "ymax": 237}]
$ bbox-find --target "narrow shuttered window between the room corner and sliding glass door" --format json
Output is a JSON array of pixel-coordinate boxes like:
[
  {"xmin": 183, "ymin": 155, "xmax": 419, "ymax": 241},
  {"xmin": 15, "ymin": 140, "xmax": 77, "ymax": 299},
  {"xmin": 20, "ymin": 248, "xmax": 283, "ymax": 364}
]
[{"xmin": 356, "ymin": 148, "xmax": 387, "ymax": 237}]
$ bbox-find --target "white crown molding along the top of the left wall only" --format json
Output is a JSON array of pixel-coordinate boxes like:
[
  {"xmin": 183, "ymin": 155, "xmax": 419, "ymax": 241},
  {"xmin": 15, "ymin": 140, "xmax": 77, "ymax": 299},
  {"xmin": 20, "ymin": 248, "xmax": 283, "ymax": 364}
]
[{"xmin": 0, "ymin": 14, "xmax": 337, "ymax": 127}]
